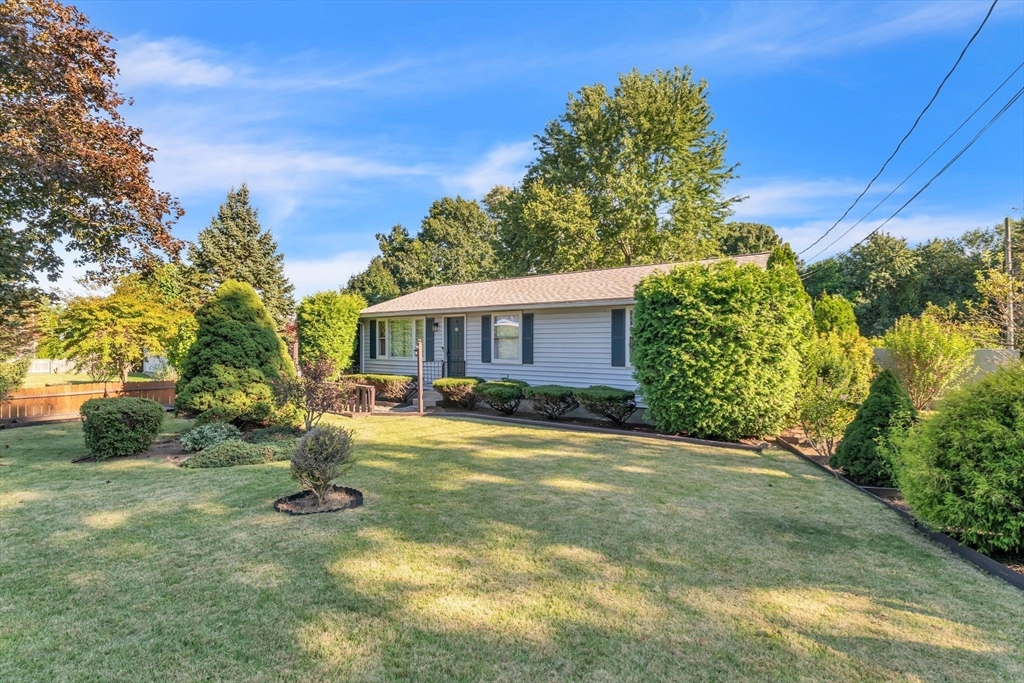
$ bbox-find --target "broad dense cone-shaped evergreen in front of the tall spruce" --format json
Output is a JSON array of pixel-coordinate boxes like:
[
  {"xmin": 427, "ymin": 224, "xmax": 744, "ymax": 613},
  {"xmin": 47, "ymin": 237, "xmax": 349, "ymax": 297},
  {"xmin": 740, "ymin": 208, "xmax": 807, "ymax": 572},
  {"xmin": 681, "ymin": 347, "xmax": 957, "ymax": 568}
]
[{"xmin": 174, "ymin": 280, "xmax": 295, "ymax": 426}]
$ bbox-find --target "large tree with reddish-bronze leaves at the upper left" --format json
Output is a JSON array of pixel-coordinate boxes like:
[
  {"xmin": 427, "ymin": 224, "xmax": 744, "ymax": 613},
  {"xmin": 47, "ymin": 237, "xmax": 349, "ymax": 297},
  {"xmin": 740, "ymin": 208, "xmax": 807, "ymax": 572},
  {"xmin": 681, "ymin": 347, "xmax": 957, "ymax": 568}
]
[{"xmin": 0, "ymin": 0, "xmax": 182, "ymax": 306}]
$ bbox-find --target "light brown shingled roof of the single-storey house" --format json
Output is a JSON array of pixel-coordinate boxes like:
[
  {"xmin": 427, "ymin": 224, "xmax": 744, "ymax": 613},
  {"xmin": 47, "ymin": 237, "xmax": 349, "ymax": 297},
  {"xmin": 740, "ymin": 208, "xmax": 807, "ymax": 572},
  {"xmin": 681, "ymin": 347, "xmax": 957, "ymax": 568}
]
[{"xmin": 362, "ymin": 253, "xmax": 769, "ymax": 315}]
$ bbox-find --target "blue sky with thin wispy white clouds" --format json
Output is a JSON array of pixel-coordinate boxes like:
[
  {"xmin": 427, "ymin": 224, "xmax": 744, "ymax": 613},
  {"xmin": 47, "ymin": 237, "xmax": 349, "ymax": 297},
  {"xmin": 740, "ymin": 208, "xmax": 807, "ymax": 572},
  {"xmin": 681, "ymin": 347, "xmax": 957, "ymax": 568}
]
[{"xmin": 77, "ymin": 0, "xmax": 1024, "ymax": 294}]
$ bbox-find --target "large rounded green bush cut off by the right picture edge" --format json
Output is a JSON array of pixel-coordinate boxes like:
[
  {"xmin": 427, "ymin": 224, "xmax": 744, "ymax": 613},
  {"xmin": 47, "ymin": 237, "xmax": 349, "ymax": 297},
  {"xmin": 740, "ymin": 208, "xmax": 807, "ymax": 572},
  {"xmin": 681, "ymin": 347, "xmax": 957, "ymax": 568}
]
[{"xmin": 896, "ymin": 362, "xmax": 1024, "ymax": 552}]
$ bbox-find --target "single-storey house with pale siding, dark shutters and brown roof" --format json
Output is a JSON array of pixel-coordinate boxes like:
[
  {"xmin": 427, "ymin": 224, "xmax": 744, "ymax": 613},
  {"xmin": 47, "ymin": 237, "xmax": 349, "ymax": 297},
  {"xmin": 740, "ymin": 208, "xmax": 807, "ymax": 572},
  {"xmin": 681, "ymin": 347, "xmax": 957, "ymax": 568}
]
[{"xmin": 359, "ymin": 253, "xmax": 768, "ymax": 389}]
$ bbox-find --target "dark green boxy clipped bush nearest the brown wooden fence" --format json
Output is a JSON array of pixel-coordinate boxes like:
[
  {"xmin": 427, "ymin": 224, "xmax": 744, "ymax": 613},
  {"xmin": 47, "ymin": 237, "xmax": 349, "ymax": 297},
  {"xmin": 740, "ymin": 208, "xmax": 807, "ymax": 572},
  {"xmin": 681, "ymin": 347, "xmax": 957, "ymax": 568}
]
[{"xmin": 80, "ymin": 396, "xmax": 166, "ymax": 460}]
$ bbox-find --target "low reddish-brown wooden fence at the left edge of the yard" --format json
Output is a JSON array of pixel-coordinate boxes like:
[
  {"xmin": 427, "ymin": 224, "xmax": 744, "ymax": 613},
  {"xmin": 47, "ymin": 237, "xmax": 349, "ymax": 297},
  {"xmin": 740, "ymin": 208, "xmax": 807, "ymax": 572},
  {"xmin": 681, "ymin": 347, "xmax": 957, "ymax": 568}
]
[{"xmin": 0, "ymin": 382, "xmax": 174, "ymax": 420}]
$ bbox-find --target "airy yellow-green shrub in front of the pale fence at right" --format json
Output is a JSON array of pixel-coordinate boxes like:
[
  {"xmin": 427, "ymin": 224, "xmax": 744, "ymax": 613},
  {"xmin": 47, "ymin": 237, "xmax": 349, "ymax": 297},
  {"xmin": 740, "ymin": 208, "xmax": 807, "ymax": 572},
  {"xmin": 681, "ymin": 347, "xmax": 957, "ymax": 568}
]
[{"xmin": 882, "ymin": 307, "xmax": 976, "ymax": 411}]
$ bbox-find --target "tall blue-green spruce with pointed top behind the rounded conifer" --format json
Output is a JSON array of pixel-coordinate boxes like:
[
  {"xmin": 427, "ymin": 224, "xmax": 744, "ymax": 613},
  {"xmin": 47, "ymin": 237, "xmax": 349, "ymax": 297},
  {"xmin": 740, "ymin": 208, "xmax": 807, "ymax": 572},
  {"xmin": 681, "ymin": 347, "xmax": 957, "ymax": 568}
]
[{"xmin": 188, "ymin": 183, "xmax": 295, "ymax": 330}]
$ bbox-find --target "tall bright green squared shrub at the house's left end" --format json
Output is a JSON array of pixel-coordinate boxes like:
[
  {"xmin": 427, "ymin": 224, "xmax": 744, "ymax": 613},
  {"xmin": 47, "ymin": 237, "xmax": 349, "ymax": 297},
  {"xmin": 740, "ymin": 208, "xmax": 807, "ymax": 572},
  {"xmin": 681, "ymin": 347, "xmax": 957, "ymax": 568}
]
[{"xmin": 295, "ymin": 291, "xmax": 367, "ymax": 371}]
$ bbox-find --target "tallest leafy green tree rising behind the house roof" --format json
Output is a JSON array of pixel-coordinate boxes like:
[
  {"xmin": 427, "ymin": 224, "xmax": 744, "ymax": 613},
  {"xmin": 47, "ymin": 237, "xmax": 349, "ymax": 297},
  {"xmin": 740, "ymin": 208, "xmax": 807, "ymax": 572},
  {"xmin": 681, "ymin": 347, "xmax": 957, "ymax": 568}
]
[{"xmin": 500, "ymin": 69, "xmax": 734, "ymax": 272}]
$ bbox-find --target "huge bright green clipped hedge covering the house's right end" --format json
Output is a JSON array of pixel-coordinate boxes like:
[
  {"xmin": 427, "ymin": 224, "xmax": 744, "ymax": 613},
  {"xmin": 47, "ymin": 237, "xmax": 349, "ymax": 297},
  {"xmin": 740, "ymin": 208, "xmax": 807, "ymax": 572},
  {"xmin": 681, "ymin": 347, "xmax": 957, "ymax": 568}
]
[{"xmin": 631, "ymin": 249, "xmax": 813, "ymax": 439}]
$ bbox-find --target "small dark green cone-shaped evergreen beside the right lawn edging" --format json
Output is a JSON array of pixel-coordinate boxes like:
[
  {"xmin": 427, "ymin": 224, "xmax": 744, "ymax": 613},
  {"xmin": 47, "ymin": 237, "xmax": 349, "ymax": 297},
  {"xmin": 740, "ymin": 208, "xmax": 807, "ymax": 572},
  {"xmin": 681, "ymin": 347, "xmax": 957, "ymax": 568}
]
[{"xmin": 828, "ymin": 370, "xmax": 916, "ymax": 486}]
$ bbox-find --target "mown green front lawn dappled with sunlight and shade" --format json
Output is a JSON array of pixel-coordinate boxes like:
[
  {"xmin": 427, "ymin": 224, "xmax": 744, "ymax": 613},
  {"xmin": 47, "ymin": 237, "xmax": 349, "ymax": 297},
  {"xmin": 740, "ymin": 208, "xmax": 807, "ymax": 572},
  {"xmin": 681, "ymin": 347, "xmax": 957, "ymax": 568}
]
[{"xmin": 0, "ymin": 418, "xmax": 1024, "ymax": 683}]
